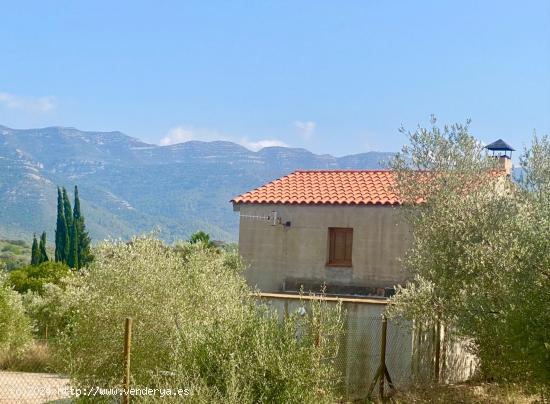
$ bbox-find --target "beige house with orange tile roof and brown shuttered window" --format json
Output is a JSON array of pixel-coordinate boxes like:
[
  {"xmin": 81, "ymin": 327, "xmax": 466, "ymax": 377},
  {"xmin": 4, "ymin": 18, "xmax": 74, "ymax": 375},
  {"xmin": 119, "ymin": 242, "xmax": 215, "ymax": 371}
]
[{"xmin": 232, "ymin": 170, "xmax": 410, "ymax": 296}]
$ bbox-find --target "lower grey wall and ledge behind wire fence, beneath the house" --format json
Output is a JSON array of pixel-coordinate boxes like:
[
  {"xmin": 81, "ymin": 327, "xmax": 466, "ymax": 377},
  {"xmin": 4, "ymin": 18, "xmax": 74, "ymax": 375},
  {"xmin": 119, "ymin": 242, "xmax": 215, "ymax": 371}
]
[{"xmin": 260, "ymin": 293, "xmax": 477, "ymax": 400}]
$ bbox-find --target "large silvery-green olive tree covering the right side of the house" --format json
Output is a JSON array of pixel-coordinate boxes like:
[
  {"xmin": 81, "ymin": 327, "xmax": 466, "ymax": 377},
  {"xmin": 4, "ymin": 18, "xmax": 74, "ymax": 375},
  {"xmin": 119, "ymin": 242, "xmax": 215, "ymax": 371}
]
[{"xmin": 390, "ymin": 118, "xmax": 550, "ymax": 384}]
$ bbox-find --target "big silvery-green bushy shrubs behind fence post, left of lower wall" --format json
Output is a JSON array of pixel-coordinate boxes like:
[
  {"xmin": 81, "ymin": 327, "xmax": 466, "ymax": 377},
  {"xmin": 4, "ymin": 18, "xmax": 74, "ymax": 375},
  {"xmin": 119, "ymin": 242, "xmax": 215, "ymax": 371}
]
[{"xmin": 58, "ymin": 238, "xmax": 341, "ymax": 403}]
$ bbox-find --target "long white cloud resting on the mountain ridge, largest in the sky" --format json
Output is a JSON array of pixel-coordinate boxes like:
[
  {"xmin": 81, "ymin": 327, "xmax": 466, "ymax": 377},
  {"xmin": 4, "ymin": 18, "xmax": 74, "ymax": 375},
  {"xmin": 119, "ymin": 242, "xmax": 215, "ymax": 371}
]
[{"xmin": 159, "ymin": 126, "xmax": 288, "ymax": 151}]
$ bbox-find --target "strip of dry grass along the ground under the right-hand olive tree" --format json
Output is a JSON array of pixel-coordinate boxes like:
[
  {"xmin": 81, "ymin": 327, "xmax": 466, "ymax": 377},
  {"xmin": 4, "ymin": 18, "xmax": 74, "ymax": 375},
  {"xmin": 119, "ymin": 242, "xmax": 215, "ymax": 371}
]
[{"xmin": 390, "ymin": 383, "xmax": 548, "ymax": 404}]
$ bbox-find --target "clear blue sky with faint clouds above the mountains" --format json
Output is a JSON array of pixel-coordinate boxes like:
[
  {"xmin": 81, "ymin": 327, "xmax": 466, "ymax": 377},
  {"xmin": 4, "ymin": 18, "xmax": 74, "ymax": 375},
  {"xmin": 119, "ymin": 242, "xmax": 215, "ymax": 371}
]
[{"xmin": 0, "ymin": 0, "xmax": 550, "ymax": 155}]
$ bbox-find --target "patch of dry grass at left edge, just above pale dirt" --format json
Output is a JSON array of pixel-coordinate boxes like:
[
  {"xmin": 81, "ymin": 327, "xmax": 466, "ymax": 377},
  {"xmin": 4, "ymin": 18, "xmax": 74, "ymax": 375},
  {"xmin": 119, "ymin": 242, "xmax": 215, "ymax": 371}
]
[{"xmin": 0, "ymin": 341, "xmax": 52, "ymax": 372}]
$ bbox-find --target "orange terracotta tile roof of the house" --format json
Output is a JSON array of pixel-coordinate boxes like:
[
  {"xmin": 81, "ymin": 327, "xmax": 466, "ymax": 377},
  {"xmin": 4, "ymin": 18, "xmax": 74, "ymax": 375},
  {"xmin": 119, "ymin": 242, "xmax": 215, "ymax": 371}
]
[{"xmin": 231, "ymin": 170, "xmax": 400, "ymax": 205}]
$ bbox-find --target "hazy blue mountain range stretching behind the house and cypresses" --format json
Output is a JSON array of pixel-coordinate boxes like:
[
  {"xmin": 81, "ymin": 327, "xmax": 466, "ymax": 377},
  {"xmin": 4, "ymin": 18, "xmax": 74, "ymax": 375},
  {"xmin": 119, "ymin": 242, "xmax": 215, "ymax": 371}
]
[{"xmin": 0, "ymin": 126, "xmax": 392, "ymax": 241}]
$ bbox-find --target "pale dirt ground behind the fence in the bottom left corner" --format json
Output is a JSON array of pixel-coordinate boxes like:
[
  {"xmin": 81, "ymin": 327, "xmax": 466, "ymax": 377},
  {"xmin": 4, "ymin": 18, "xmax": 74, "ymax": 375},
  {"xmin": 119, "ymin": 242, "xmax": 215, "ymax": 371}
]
[{"xmin": 0, "ymin": 371, "xmax": 69, "ymax": 404}]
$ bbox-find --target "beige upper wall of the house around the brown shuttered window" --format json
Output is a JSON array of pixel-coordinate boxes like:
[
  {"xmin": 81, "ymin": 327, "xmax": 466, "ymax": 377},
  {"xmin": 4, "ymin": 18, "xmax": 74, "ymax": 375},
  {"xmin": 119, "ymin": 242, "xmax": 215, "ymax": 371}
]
[{"xmin": 238, "ymin": 204, "xmax": 410, "ymax": 292}]
